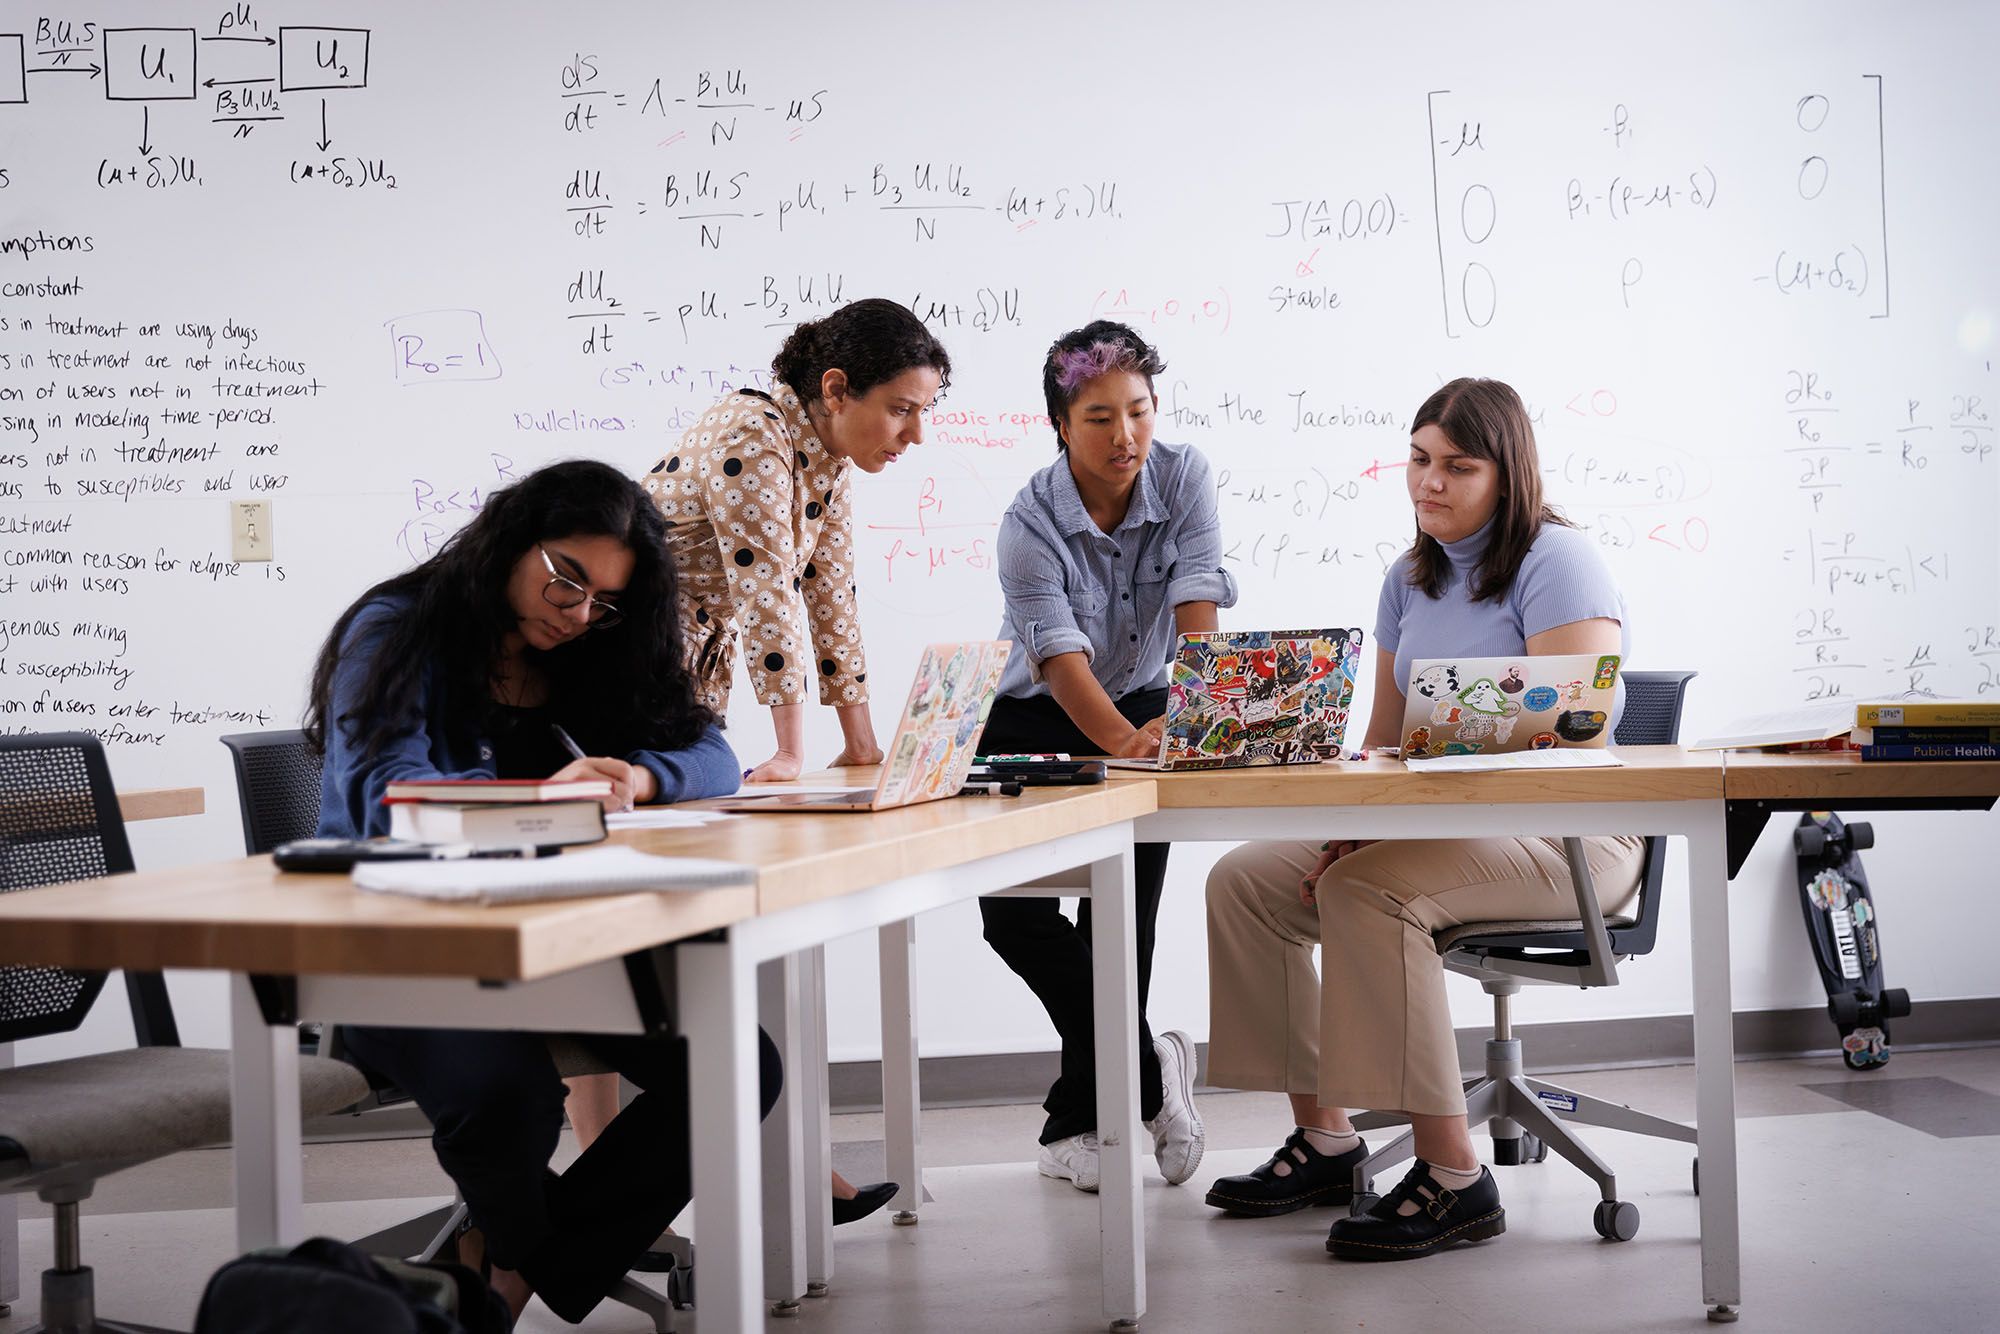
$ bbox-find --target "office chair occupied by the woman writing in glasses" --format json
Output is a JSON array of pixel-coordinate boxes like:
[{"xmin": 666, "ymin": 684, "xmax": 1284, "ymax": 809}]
[{"xmin": 220, "ymin": 730, "xmax": 694, "ymax": 1334}]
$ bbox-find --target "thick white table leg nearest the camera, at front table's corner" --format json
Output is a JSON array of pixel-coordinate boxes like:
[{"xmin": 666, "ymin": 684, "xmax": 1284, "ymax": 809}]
[{"xmin": 676, "ymin": 940, "xmax": 764, "ymax": 1334}]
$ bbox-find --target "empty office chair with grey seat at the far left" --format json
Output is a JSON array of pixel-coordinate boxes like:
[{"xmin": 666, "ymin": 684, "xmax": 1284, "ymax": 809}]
[{"xmin": 0, "ymin": 732, "xmax": 368, "ymax": 1334}]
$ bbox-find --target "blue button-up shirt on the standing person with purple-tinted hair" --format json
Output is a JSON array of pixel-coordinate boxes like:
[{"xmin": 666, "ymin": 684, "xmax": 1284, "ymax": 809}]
[{"xmin": 998, "ymin": 442, "xmax": 1236, "ymax": 700}]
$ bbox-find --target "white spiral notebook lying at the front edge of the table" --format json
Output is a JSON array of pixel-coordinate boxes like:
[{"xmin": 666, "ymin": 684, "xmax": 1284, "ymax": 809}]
[{"xmin": 354, "ymin": 848, "xmax": 752, "ymax": 904}]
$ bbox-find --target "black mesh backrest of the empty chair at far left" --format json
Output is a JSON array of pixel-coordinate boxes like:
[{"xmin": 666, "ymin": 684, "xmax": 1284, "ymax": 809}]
[{"xmin": 0, "ymin": 732, "xmax": 132, "ymax": 1042}]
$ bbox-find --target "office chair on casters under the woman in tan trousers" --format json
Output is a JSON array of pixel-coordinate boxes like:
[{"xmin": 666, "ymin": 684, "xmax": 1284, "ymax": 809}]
[{"xmin": 1352, "ymin": 672, "xmax": 1698, "ymax": 1242}]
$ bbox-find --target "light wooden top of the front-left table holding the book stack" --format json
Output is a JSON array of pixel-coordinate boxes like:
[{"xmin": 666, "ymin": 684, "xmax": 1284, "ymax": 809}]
[{"xmin": 0, "ymin": 772, "xmax": 1152, "ymax": 982}]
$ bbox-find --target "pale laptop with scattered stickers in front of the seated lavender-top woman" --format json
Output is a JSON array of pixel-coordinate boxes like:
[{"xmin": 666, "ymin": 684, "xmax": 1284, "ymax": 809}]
[{"xmin": 1402, "ymin": 654, "xmax": 1618, "ymax": 768}]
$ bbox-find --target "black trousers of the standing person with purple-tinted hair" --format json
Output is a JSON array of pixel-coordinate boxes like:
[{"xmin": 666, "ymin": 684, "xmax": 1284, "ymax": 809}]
[{"xmin": 980, "ymin": 690, "xmax": 1170, "ymax": 1144}]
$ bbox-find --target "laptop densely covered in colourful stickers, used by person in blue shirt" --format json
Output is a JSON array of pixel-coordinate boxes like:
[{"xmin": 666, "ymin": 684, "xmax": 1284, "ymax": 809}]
[{"xmin": 1106, "ymin": 630, "xmax": 1362, "ymax": 772}]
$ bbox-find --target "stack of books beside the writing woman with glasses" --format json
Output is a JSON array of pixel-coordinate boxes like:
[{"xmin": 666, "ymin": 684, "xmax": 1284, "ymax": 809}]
[{"xmin": 382, "ymin": 778, "xmax": 612, "ymax": 848}]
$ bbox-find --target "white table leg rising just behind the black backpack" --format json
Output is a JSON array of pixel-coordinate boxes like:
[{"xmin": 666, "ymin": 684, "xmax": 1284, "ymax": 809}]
[{"xmin": 230, "ymin": 972, "xmax": 306, "ymax": 1250}]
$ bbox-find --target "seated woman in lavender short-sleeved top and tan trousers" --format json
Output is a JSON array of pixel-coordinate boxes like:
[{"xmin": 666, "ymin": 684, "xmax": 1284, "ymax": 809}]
[{"xmin": 1208, "ymin": 380, "xmax": 1644, "ymax": 1260}]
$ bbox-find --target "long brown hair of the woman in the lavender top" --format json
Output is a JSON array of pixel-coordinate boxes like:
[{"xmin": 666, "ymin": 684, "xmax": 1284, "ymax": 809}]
[{"xmin": 1410, "ymin": 376, "xmax": 1572, "ymax": 602}]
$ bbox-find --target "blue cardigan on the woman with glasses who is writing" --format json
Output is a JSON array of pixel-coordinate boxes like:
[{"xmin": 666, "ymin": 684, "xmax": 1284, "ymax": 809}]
[{"xmin": 318, "ymin": 598, "xmax": 742, "ymax": 838}]
